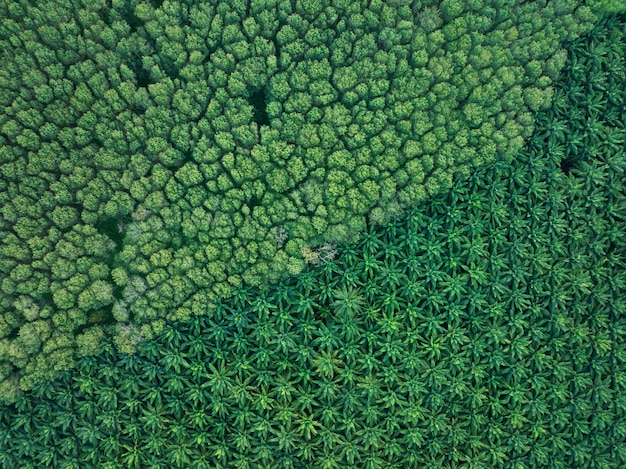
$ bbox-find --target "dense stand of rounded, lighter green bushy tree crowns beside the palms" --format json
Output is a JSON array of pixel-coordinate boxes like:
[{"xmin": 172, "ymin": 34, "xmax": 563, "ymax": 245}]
[{"xmin": 0, "ymin": 0, "xmax": 603, "ymax": 389}]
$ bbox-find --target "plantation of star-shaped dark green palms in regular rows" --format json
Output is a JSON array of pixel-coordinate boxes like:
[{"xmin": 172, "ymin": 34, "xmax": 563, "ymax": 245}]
[{"xmin": 0, "ymin": 12, "xmax": 626, "ymax": 469}]
